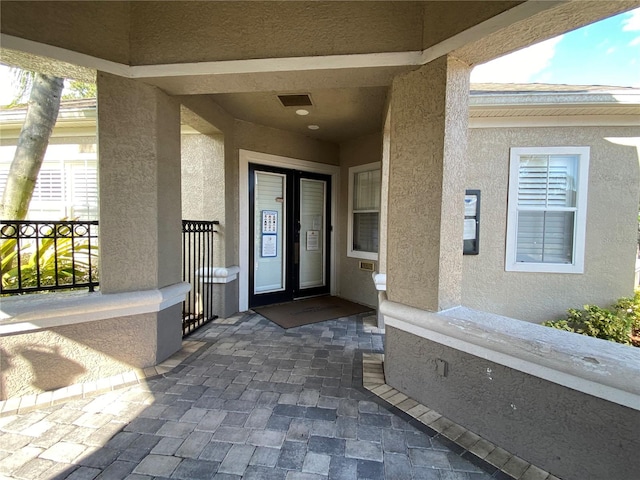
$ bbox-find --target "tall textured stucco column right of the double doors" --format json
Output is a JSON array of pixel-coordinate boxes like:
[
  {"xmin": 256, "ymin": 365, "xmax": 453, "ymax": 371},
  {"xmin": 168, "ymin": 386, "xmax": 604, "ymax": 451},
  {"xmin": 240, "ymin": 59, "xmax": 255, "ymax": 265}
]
[{"xmin": 387, "ymin": 57, "xmax": 471, "ymax": 311}]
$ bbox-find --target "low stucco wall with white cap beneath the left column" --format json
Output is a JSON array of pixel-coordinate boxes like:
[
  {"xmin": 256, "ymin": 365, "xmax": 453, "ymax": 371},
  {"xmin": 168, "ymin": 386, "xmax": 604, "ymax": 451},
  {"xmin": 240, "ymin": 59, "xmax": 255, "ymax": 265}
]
[{"xmin": 0, "ymin": 283, "xmax": 189, "ymax": 400}]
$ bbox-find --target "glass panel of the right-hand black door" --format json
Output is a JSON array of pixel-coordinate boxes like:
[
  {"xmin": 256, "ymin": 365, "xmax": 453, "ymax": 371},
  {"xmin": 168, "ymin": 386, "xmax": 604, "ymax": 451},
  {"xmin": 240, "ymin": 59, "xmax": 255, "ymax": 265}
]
[{"xmin": 299, "ymin": 178, "xmax": 326, "ymax": 289}]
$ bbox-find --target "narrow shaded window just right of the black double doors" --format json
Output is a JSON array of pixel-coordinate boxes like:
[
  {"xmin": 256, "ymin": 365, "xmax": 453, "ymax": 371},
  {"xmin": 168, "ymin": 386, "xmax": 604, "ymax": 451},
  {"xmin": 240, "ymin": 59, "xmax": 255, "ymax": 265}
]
[{"xmin": 347, "ymin": 162, "xmax": 381, "ymax": 260}]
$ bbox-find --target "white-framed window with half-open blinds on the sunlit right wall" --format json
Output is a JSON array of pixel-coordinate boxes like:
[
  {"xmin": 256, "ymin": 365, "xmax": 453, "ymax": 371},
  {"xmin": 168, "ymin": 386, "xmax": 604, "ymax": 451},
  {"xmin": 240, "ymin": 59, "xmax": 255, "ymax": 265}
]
[{"xmin": 505, "ymin": 147, "xmax": 589, "ymax": 273}]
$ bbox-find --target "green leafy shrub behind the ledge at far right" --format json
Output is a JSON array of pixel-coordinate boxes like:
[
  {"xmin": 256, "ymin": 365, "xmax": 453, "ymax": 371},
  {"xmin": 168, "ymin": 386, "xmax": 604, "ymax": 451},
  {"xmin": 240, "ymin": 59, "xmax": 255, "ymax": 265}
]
[{"xmin": 543, "ymin": 290, "xmax": 640, "ymax": 346}]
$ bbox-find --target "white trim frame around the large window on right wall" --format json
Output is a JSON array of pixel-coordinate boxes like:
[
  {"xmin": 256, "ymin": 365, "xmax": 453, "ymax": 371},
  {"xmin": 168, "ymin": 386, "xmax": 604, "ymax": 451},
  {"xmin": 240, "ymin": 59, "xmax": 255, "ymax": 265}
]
[{"xmin": 505, "ymin": 147, "xmax": 590, "ymax": 273}]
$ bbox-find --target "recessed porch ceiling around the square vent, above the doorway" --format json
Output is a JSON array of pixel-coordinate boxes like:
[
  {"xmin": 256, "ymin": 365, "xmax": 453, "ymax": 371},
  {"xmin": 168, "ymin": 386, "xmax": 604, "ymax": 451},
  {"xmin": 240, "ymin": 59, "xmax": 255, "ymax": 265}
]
[{"xmin": 138, "ymin": 64, "xmax": 419, "ymax": 143}]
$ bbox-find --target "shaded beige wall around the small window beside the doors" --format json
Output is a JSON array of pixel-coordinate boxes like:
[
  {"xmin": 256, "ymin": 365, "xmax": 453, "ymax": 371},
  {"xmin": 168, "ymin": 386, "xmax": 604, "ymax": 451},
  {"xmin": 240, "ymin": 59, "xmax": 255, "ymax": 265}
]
[{"xmin": 336, "ymin": 133, "xmax": 382, "ymax": 308}]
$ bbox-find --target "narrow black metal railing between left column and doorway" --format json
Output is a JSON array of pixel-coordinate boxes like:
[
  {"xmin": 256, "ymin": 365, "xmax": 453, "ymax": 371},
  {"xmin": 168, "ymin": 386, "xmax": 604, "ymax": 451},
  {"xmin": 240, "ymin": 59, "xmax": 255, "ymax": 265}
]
[{"xmin": 182, "ymin": 220, "xmax": 220, "ymax": 336}]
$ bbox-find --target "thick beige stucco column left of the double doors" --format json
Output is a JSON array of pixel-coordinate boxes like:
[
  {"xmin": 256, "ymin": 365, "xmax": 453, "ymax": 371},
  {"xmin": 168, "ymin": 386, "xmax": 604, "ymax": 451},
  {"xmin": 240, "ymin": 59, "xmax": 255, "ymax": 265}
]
[{"xmin": 98, "ymin": 73, "xmax": 182, "ymax": 293}]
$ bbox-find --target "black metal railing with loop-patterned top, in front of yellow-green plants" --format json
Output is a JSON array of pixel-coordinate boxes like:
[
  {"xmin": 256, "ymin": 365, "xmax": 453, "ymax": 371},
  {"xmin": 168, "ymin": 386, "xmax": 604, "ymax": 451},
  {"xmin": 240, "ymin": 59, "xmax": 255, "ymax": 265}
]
[{"xmin": 0, "ymin": 220, "xmax": 99, "ymax": 295}]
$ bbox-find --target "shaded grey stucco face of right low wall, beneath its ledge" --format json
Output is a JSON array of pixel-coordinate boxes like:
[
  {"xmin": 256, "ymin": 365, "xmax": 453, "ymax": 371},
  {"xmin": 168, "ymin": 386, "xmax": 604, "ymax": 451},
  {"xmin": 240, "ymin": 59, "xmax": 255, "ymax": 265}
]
[{"xmin": 384, "ymin": 325, "xmax": 640, "ymax": 480}]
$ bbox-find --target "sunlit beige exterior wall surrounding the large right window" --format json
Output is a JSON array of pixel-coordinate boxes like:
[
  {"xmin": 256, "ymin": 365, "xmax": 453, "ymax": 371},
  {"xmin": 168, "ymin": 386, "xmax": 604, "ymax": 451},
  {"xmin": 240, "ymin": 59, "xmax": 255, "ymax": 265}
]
[{"xmin": 462, "ymin": 127, "xmax": 640, "ymax": 322}]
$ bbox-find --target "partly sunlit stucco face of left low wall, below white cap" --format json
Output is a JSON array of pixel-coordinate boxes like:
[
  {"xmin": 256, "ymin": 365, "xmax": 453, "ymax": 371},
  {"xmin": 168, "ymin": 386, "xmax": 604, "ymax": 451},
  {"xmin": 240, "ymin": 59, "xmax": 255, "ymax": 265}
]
[{"xmin": 0, "ymin": 314, "xmax": 159, "ymax": 400}]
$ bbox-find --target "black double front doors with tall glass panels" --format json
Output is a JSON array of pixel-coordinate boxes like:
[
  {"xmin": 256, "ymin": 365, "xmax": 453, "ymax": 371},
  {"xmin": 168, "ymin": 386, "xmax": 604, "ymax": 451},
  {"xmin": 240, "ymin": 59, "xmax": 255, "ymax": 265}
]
[{"xmin": 249, "ymin": 164, "xmax": 331, "ymax": 307}]
